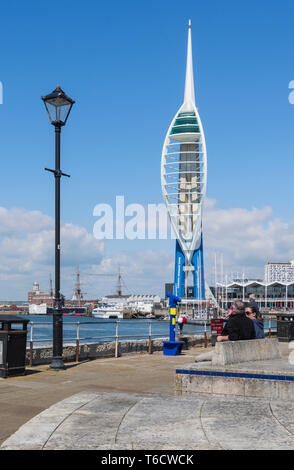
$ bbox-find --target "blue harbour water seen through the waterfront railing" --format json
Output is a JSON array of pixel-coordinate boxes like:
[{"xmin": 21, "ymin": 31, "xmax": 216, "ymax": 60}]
[{"xmin": 17, "ymin": 315, "xmax": 276, "ymax": 344}]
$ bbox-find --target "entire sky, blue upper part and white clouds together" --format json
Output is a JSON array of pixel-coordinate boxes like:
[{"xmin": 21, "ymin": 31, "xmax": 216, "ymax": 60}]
[{"xmin": 0, "ymin": 0, "xmax": 294, "ymax": 300}]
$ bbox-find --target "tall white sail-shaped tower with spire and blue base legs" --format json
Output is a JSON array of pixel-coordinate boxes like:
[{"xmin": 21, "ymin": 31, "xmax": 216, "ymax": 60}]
[{"xmin": 161, "ymin": 21, "xmax": 207, "ymax": 301}]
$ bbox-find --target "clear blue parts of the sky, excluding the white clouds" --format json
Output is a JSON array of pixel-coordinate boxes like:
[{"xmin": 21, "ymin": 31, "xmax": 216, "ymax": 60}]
[{"xmin": 0, "ymin": 0, "xmax": 294, "ymax": 298}]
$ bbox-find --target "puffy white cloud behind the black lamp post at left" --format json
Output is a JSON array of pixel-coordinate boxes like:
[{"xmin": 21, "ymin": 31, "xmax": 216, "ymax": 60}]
[{"xmin": 0, "ymin": 207, "xmax": 104, "ymax": 300}]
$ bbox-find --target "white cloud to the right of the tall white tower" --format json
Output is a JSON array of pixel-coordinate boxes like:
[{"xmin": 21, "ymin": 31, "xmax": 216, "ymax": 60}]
[{"xmin": 203, "ymin": 200, "xmax": 294, "ymax": 278}]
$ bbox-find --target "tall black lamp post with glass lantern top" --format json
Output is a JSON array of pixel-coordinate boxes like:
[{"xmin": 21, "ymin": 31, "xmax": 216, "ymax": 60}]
[{"xmin": 42, "ymin": 86, "xmax": 74, "ymax": 370}]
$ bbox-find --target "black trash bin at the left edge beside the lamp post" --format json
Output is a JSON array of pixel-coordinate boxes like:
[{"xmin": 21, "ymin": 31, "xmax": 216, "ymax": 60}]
[{"xmin": 0, "ymin": 315, "xmax": 29, "ymax": 378}]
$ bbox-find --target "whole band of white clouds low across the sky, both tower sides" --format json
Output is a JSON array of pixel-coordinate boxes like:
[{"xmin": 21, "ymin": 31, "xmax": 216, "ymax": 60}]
[{"xmin": 0, "ymin": 199, "xmax": 294, "ymax": 300}]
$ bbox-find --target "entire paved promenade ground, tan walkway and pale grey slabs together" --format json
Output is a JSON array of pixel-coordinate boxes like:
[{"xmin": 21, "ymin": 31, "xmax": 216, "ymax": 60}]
[{"xmin": 0, "ymin": 343, "xmax": 294, "ymax": 450}]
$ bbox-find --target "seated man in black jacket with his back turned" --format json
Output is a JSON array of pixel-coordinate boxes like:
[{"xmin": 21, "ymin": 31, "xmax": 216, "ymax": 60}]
[{"xmin": 217, "ymin": 300, "xmax": 256, "ymax": 341}]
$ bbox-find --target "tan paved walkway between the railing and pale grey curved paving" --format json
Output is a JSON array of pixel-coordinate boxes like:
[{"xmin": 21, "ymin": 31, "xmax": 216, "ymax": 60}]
[{"xmin": 0, "ymin": 347, "xmax": 209, "ymax": 444}]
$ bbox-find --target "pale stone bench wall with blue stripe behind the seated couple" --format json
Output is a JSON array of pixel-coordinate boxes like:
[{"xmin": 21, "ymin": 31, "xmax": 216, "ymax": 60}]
[{"xmin": 175, "ymin": 338, "xmax": 294, "ymax": 400}]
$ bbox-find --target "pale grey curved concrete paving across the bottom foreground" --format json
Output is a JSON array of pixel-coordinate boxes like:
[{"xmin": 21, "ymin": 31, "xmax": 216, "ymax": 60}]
[{"xmin": 1, "ymin": 393, "xmax": 294, "ymax": 450}]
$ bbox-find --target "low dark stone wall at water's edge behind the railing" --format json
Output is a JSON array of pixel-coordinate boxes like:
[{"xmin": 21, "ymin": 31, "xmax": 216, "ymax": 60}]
[{"xmin": 26, "ymin": 336, "xmax": 204, "ymax": 365}]
